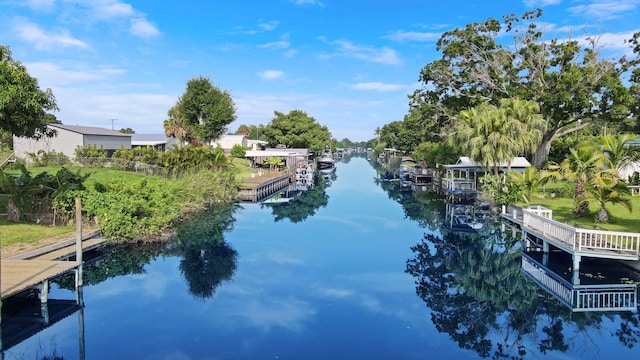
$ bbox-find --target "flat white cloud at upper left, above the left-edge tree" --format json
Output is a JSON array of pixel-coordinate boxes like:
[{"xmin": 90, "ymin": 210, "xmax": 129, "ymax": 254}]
[{"xmin": 13, "ymin": 18, "xmax": 89, "ymax": 50}]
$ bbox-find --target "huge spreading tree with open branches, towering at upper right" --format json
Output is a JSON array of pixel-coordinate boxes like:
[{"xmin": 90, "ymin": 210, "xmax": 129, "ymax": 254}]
[{"xmin": 410, "ymin": 10, "xmax": 635, "ymax": 167}]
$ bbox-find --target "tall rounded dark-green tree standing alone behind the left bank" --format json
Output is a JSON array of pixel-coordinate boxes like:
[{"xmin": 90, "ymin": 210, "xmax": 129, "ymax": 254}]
[{"xmin": 164, "ymin": 76, "xmax": 236, "ymax": 143}]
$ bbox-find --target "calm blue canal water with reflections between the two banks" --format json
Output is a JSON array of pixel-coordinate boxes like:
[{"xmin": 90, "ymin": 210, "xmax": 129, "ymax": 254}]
[{"xmin": 2, "ymin": 157, "xmax": 640, "ymax": 359}]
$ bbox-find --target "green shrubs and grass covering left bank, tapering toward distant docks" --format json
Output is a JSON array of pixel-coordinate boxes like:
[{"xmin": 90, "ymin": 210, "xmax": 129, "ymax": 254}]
[{"xmin": 0, "ymin": 158, "xmax": 283, "ymax": 253}]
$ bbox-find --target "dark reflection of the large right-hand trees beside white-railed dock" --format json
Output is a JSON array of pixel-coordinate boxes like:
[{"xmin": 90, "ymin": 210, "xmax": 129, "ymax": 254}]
[{"xmin": 406, "ymin": 221, "xmax": 640, "ymax": 359}]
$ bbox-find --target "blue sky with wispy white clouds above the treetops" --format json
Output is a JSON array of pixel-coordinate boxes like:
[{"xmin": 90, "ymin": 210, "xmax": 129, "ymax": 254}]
[{"xmin": 0, "ymin": 0, "xmax": 640, "ymax": 141}]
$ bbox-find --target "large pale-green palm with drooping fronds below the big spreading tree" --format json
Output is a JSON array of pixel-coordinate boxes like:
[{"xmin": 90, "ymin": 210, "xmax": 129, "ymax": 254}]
[{"xmin": 449, "ymin": 99, "xmax": 545, "ymax": 175}]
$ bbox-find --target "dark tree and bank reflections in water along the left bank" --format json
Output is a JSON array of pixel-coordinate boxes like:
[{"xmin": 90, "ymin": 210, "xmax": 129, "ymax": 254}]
[{"xmin": 0, "ymin": 206, "xmax": 237, "ymax": 359}]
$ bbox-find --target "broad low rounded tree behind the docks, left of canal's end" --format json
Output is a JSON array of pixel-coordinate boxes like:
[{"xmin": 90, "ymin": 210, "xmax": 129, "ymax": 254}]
[{"xmin": 264, "ymin": 110, "xmax": 331, "ymax": 151}]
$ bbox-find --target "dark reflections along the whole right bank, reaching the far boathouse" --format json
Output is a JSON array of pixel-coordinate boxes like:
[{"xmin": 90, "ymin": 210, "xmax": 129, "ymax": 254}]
[{"xmin": 377, "ymin": 167, "xmax": 640, "ymax": 359}]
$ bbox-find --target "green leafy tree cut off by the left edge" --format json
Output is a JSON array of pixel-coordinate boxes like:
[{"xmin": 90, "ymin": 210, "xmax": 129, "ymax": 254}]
[{"xmin": 0, "ymin": 45, "xmax": 58, "ymax": 138}]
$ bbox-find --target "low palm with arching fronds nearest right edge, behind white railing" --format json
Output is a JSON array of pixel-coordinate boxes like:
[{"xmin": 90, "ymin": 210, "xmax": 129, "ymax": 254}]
[{"xmin": 582, "ymin": 169, "xmax": 633, "ymax": 223}]
